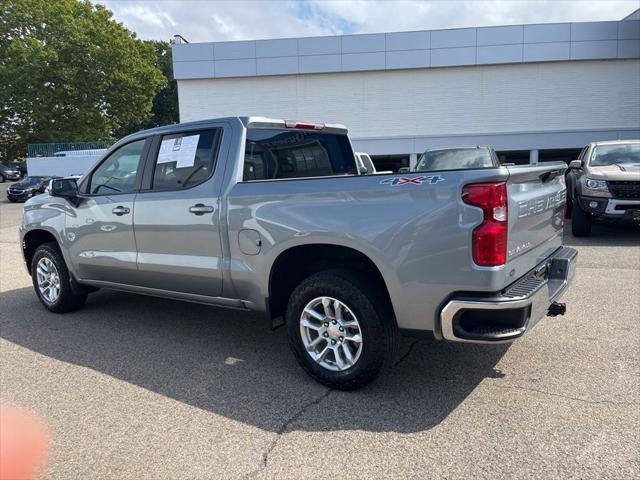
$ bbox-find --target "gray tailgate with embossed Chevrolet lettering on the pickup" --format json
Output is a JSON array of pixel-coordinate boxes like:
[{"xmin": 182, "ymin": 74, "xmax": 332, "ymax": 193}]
[{"xmin": 505, "ymin": 162, "xmax": 567, "ymax": 285}]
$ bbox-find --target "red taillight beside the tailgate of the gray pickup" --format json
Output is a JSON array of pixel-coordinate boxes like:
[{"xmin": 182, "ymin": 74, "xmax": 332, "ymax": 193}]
[{"xmin": 462, "ymin": 182, "xmax": 509, "ymax": 267}]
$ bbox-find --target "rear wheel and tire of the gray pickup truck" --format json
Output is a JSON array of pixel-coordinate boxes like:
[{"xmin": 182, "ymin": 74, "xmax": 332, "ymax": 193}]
[{"xmin": 286, "ymin": 270, "xmax": 397, "ymax": 390}]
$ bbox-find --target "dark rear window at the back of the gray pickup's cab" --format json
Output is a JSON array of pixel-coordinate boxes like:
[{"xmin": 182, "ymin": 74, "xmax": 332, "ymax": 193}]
[{"xmin": 243, "ymin": 128, "xmax": 356, "ymax": 181}]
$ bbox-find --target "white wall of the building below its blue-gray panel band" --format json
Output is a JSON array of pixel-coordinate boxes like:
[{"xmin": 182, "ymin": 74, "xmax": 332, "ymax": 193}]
[{"xmin": 178, "ymin": 59, "xmax": 640, "ymax": 153}]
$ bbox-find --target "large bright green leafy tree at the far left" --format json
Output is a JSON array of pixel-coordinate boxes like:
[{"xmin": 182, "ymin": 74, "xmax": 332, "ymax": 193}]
[{"xmin": 0, "ymin": 0, "xmax": 166, "ymax": 160}]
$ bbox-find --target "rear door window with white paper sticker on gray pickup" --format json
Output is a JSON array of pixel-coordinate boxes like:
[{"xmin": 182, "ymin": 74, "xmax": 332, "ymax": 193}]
[{"xmin": 152, "ymin": 129, "xmax": 221, "ymax": 190}]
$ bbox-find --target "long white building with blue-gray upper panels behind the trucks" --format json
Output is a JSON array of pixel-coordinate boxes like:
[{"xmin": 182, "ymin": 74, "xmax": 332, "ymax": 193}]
[{"xmin": 173, "ymin": 12, "xmax": 640, "ymax": 172}]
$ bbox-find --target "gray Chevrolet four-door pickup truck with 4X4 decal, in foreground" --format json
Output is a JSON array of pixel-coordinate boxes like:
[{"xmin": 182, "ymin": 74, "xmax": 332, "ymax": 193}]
[{"xmin": 20, "ymin": 117, "xmax": 576, "ymax": 389}]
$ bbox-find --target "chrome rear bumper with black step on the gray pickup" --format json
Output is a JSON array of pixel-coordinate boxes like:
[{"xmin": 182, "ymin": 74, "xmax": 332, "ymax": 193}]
[{"xmin": 440, "ymin": 247, "xmax": 578, "ymax": 343}]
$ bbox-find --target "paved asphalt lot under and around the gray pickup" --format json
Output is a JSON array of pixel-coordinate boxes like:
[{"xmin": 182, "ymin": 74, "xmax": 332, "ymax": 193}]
[{"xmin": 0, "ymin": 184, "xmax": 640, "ymax": 479}]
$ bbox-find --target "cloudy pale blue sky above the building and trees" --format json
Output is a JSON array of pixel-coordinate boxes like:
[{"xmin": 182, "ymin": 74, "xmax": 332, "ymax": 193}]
[{"xmin": 96, "ymin": 0, "xmax": 640, "ymax": 42}]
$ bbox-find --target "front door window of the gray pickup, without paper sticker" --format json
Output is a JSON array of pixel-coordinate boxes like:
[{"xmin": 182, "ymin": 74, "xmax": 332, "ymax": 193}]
[{"xmin": 86, "ymin": 139, "xmax": 146, "ymax": 195}]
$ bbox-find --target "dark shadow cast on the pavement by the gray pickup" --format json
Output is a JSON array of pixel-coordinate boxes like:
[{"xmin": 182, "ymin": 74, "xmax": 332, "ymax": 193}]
[{"xmin": 0, "ymin": 288, "xmax": 508, "ymax": 432}]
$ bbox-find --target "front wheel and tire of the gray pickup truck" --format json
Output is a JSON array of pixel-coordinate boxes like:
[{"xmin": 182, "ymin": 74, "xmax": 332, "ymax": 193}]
[{"xmin": 31, "ymin": 243, "xmax": 87, "ymax": 313}]
